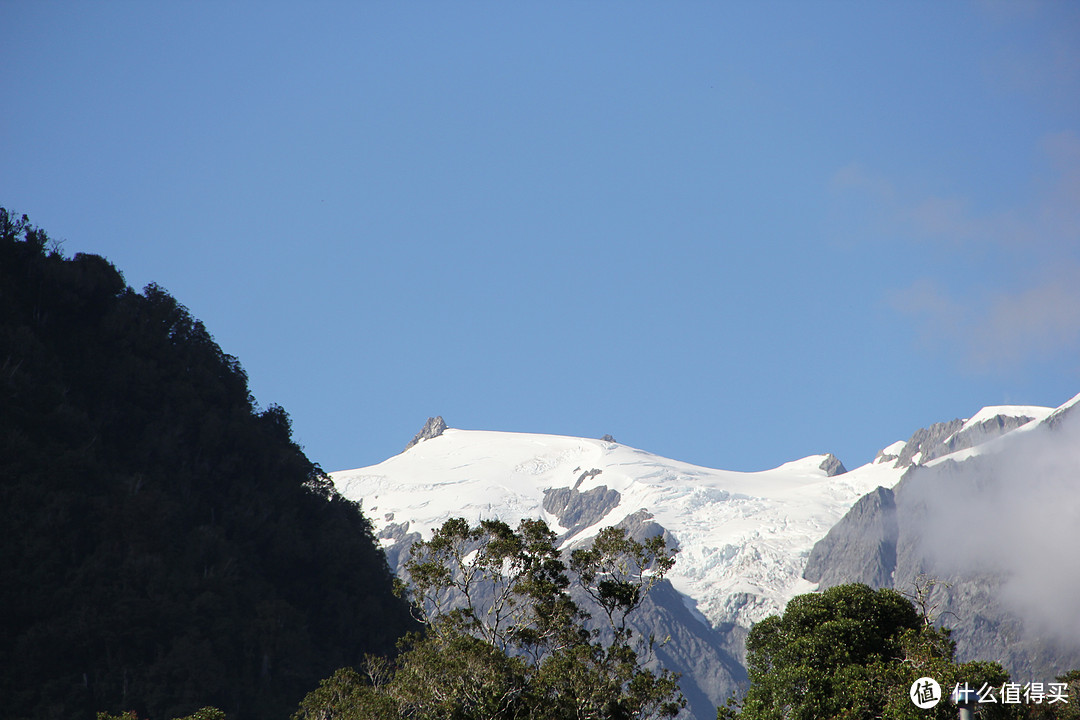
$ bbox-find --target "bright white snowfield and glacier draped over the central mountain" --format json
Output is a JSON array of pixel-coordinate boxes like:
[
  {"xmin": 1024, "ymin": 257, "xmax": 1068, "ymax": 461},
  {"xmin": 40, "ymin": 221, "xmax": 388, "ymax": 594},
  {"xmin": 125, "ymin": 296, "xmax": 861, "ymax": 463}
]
[{"xmin": 332, "ymin": 429, "xmax": 903, "ymax": 627}]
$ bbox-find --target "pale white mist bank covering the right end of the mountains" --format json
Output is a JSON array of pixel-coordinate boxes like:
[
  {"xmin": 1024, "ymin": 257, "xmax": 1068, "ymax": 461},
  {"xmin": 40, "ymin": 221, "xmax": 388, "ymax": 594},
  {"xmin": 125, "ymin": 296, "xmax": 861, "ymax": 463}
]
[{"xmin": 906, "ymin": 411, "xmax": 1080, "ymax": 640}]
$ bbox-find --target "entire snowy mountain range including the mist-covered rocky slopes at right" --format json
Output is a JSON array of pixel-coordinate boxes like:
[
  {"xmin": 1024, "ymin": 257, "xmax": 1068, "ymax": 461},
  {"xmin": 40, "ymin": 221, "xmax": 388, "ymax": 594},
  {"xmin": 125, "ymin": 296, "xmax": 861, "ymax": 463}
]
[{"xmin": 347, "ymin": 397, "xmax": 1080, "ymax": 718}]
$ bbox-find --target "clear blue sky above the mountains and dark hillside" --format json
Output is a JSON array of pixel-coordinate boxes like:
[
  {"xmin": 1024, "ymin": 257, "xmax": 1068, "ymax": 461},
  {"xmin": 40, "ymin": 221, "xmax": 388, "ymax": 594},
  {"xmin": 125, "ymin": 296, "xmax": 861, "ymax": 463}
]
[{"xmin": 0, "ymin": 0, "xmax": 1080, "ymax": 471}]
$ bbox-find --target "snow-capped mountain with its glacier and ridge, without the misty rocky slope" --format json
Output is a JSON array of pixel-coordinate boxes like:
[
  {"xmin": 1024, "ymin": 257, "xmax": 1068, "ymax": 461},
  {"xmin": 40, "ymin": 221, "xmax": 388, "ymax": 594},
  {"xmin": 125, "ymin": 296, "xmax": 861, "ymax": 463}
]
[{"xmin": 332, "ymin": 397, "xmax": 1075, "ymax": 717}]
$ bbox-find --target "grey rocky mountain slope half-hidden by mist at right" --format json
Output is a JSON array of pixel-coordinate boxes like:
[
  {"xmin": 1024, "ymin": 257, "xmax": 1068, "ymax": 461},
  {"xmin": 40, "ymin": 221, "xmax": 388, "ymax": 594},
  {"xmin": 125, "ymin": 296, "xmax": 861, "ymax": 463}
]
[{"xmin": 804, "ymin": 412, "xmax": 1080, "ymax": 681}]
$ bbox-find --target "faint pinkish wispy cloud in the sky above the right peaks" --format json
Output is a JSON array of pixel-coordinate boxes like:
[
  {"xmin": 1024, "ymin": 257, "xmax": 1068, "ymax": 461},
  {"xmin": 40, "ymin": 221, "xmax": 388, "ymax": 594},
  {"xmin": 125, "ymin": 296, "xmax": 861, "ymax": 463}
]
[{"xmin": 832, "ymin": 133, "xmax": 1080, "ymax": 371}]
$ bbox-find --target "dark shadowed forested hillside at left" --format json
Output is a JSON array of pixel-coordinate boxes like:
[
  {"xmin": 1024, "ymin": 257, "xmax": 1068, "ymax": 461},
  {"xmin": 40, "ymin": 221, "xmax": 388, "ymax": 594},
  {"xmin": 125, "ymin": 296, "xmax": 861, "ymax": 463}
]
[{"xmin": 0, "ymin": 209, "xmax": 410, "ymax": 719}]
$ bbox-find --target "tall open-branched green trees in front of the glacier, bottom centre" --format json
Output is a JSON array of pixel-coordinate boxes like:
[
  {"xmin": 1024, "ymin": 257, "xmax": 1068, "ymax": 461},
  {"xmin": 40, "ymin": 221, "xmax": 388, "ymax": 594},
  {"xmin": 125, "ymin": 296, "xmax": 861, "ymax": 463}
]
[{"xmin": 294, "ymin": 518, "xmax": 685, "ymax": 720}]
